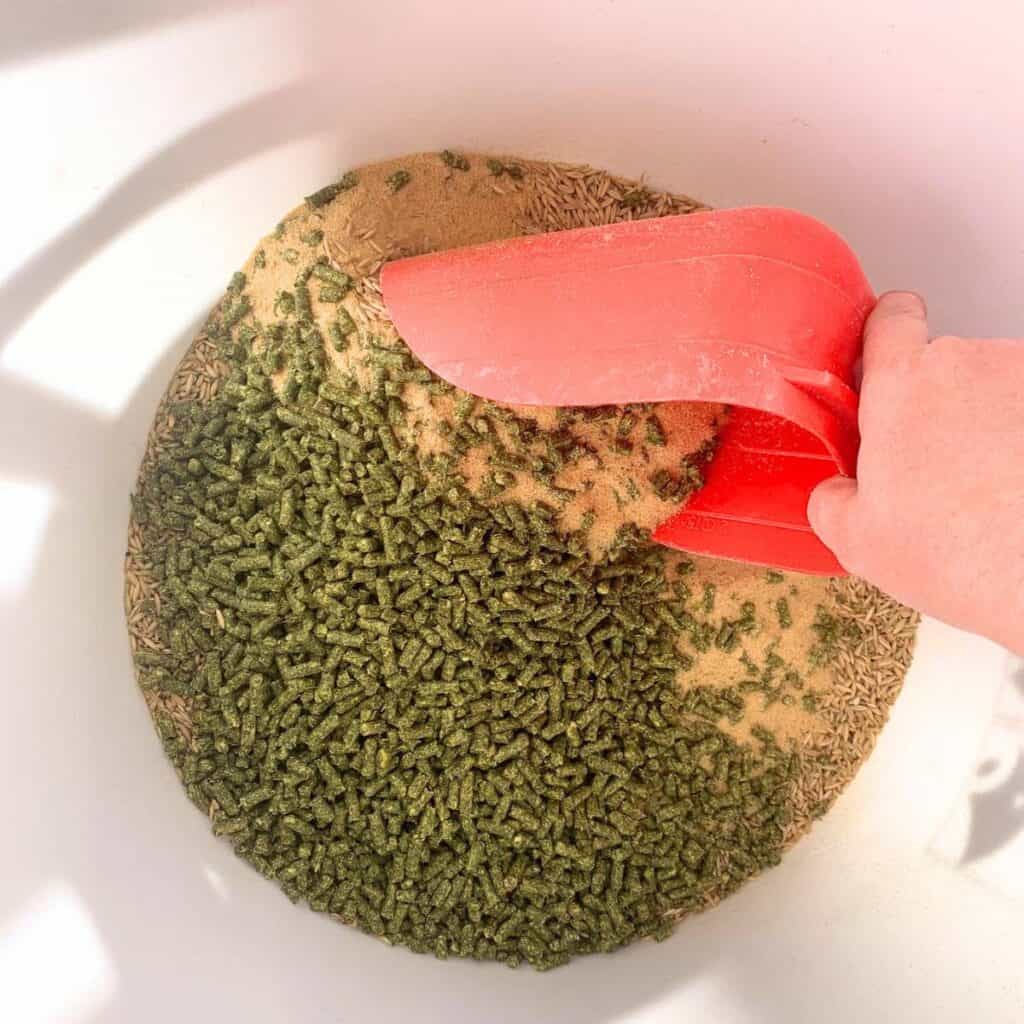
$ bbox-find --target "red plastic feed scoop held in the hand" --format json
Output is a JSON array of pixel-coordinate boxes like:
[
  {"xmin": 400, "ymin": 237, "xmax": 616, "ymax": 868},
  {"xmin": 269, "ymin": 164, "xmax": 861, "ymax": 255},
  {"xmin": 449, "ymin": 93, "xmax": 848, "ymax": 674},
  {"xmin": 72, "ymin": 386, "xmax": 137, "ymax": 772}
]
[{"xmin": 381, "ymin": 207, "xmax": 874, "ymax": 574}]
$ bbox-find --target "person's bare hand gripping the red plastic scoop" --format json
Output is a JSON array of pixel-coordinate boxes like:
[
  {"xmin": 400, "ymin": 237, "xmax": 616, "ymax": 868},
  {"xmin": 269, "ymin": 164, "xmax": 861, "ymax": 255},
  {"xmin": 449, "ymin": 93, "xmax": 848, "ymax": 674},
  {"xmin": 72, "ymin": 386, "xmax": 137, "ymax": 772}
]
[{"xmin": 807, "ymin": 292, "xmax": 1024, "ymax": 653}]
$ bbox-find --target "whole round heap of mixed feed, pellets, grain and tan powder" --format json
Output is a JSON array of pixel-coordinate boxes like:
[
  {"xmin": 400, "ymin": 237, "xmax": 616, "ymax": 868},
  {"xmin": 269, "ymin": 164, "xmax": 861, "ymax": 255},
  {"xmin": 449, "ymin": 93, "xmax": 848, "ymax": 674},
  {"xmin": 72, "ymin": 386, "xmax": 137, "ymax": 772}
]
[{"xmin": 126, "ymin": 151, "xmax": 915, "ymax": 968}]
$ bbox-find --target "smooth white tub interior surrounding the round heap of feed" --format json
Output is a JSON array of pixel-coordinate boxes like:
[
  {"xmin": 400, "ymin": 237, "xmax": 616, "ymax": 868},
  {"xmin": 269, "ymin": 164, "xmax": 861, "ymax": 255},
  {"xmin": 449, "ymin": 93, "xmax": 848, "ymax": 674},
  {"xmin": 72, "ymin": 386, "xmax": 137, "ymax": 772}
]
[{"xmin": 0, "ymin": 0, "xmax": 1024, "ymax": 1024}]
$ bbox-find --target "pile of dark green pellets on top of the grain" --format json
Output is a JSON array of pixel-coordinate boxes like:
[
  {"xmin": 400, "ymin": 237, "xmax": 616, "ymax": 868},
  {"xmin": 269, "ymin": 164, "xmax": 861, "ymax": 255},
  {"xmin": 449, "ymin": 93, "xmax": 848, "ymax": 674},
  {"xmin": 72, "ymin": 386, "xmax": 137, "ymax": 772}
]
[{"xmin": 133, "ymin": 264, "xmax": 797, "ymax": 969}]
